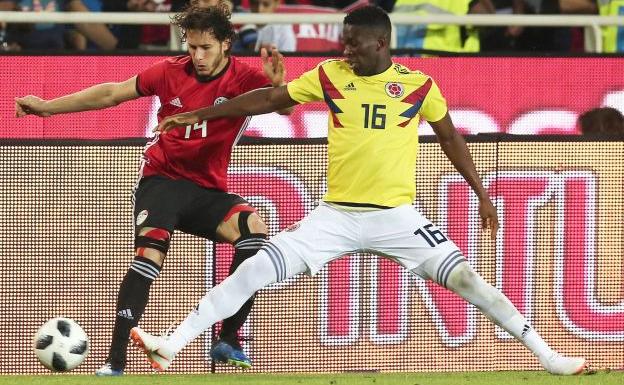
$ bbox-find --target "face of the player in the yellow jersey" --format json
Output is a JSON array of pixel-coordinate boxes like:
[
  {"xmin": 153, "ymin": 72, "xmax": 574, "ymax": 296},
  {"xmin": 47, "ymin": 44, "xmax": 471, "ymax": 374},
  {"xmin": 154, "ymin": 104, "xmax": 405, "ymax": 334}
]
[{"xmin": 342, "ymin": 24, "xmax": 382, "ymax": 76}]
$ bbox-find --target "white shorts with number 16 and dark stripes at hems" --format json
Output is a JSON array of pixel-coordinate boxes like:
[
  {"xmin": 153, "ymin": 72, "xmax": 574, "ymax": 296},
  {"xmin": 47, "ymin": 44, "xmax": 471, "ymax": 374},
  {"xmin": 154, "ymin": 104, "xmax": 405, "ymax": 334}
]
[{"xmin": 264, "ymin": 203, "xmax": 465, "ymax": 286}]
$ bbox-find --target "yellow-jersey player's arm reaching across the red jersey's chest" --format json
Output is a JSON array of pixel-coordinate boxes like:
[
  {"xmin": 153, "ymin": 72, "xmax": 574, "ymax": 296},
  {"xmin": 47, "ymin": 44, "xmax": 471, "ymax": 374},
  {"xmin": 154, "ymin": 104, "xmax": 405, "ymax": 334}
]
[{"xmin": 155, "ymin": 85, "xmax": 298, "ymax": 132}]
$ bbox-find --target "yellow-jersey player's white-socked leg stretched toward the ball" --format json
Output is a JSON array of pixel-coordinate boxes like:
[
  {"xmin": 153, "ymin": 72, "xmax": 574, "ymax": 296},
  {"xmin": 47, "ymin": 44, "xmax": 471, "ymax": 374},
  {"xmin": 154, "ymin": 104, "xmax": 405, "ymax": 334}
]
[{"xmin": 132, "ymin": 244, "xmax": 307, "ymax": 369}]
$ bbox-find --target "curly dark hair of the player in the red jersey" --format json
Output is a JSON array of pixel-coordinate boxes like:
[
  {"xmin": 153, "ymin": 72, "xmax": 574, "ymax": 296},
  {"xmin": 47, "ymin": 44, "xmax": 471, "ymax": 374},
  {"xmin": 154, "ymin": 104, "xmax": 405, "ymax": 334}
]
[{"xmin": 171, "ymin": 2, "xmax": 236, "ymax": 42}]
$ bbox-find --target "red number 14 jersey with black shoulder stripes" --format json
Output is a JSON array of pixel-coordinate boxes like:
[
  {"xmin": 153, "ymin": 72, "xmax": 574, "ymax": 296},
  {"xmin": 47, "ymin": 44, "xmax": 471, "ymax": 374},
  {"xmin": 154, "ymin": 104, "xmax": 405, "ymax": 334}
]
[{"xmin": 137, "ymin": 55, "xmax": 271, "ymax": 191}]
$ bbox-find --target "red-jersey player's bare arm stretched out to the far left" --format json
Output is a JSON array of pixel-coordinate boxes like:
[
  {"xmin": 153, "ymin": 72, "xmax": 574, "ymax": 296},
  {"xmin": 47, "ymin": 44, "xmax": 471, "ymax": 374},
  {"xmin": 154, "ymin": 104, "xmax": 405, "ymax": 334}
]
[{"xmin": 15, "ymin": 76, "xmax": 141, "ymax": 118}]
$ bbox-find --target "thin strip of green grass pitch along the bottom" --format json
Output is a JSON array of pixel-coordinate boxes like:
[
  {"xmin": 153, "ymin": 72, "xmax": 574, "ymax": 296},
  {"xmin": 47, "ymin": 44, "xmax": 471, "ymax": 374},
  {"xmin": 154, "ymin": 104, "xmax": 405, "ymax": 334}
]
[{"xmin": 0, "ymin": 371, "xmax": 624, "ymax": 385}]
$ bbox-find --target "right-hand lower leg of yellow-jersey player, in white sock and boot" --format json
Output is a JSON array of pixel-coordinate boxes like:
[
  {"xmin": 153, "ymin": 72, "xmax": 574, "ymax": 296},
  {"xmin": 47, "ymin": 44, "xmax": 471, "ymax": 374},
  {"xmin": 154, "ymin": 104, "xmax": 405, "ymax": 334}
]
[{"xmin": 442, "ymin": 261, "xmax": 589, "ymax": 375}]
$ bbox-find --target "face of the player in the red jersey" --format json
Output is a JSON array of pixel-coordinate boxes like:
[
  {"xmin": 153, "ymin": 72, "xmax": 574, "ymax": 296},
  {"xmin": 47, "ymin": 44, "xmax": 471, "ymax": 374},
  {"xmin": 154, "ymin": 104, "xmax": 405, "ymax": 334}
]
[{"xmin": 186, "ymin": 30, "xmax": 230, "ymax": 76}]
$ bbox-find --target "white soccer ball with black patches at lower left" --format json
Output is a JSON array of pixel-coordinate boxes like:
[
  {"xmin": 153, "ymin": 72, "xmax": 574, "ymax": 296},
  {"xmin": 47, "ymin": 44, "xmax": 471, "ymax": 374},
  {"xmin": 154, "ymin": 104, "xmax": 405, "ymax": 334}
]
[{"xmin": 33, "ymin": 318, "xmax": 89, "ymax": 372}]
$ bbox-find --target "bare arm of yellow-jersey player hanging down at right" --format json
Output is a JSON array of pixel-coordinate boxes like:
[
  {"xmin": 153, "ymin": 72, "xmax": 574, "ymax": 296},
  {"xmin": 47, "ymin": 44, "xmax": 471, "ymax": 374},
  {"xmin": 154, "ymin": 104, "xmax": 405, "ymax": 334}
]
[{"xmin": 429, "ymin": 112, "xmax": 498, "ymax": 239}]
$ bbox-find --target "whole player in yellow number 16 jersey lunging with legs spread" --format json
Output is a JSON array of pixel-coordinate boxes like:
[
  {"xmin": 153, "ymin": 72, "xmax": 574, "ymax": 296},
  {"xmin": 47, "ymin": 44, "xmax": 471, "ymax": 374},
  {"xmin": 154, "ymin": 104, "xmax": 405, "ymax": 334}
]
[{"xmin": 131, "ymin": 6, "xmax": 587, "ymax": 374}]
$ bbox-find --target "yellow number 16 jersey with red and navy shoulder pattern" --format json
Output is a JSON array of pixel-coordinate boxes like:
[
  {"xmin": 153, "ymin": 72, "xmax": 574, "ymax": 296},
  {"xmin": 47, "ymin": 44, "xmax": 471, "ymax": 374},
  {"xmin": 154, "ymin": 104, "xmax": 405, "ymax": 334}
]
[{"xmin": 288, "ymin": 59, "xmax": 447, "ymax": 207}]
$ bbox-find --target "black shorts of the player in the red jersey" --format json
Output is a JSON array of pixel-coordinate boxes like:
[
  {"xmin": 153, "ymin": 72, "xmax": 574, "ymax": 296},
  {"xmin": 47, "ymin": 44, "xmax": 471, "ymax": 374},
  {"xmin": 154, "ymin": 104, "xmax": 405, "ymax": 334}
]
[{"xmin": 134, "ymin": 175, "xmax": 249, "ymax": 240}]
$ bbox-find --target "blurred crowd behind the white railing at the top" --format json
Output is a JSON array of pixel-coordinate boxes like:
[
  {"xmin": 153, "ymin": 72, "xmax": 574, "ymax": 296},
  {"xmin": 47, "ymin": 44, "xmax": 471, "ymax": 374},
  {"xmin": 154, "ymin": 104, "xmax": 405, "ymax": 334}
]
[{"xmin": 0, "ymin": 0, "xmax": 624, "ymax": 53}]
